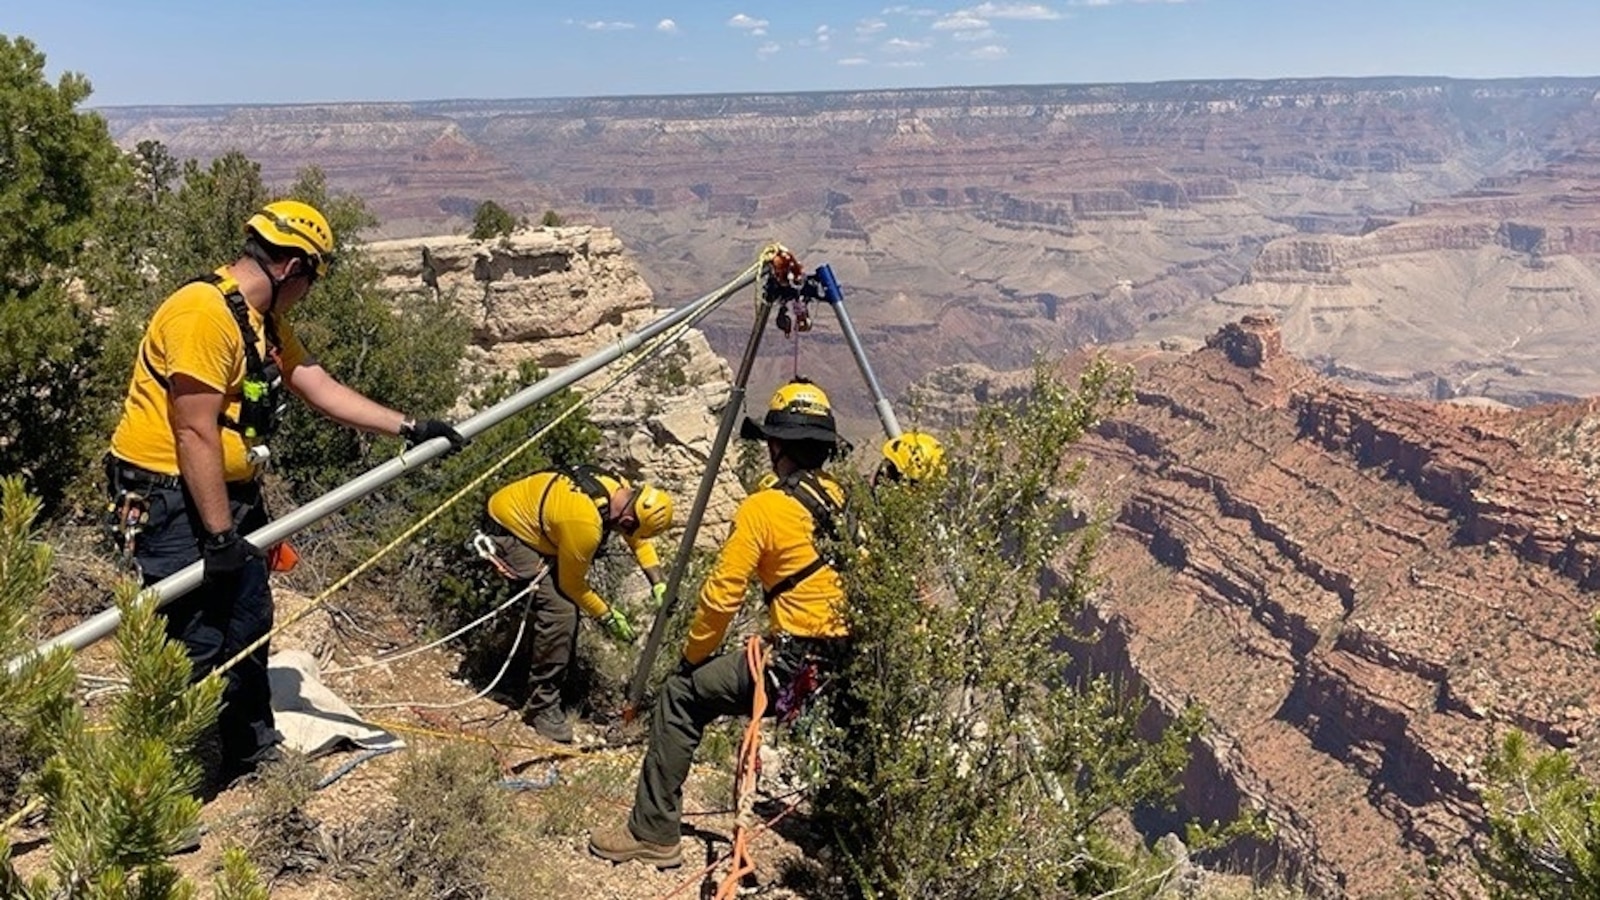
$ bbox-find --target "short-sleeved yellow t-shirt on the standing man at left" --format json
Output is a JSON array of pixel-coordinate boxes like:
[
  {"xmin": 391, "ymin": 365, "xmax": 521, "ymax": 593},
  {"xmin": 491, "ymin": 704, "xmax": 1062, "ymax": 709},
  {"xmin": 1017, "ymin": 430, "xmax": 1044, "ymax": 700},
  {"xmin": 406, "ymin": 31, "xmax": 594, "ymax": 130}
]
[{"xmin": 110, "ymin": 266, "xmax": 307, "ymax": 482}]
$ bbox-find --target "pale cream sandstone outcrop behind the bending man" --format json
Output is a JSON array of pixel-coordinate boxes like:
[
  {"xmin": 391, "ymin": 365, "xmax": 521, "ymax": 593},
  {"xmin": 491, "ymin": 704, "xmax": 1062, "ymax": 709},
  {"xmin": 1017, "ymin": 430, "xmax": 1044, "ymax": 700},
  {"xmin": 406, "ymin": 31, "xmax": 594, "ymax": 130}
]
[{"xmin": 365, "ymin": 226, "xmax": 744, "ymax": 548}]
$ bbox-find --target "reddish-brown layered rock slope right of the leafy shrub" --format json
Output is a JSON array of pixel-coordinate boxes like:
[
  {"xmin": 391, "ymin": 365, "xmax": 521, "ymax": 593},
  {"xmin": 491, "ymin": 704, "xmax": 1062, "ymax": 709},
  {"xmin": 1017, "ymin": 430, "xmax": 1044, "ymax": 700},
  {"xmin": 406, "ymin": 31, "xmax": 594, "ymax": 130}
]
[{"xmin": 931, "ymin": 317, "xmax": 1600, "ymax": 897}]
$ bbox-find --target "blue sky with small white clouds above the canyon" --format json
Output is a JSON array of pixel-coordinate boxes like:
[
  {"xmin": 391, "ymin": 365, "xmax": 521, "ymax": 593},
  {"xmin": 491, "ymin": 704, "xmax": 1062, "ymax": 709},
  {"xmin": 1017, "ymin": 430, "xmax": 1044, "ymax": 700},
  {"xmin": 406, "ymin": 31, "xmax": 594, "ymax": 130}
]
[{"xmin": 9, "ymin": 0, "xmax": 1600, "ymax": 106}]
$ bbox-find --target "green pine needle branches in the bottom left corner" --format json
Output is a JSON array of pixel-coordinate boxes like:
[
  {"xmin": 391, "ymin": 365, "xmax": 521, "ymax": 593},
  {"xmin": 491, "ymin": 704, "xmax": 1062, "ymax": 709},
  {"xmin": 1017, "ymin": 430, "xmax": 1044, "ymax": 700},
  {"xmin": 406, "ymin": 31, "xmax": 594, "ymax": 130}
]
[{"xmin": 0, "ymin": 477, "xmax": 261, "ymax": 900}]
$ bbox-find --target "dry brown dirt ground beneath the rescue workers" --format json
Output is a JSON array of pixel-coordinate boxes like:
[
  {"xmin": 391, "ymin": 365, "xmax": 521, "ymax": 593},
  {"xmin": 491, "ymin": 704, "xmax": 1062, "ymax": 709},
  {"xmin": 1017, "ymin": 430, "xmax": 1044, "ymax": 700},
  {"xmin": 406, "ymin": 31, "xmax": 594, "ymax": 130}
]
[{"xmin": 13, "ymin": 566, "xmax": 810, "ymax": 900}]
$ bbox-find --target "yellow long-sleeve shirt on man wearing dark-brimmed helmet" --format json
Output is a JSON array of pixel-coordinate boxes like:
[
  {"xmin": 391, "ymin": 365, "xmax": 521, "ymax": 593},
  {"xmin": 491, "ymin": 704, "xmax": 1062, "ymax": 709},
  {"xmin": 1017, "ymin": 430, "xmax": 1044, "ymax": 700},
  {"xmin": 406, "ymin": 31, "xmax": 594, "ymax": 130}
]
[{"xmin": 683, "ymin": 476, "xmax": 848, "ymax": 665}]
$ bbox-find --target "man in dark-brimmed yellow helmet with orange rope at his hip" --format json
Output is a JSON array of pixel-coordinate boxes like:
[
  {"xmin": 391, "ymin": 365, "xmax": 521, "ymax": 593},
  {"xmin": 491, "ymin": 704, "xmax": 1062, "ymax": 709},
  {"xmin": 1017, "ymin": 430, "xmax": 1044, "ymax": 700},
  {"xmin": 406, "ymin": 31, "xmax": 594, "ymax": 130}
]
[{"xmin": 589, "ymin": 381, "xmax": 848, "ymax": 868}]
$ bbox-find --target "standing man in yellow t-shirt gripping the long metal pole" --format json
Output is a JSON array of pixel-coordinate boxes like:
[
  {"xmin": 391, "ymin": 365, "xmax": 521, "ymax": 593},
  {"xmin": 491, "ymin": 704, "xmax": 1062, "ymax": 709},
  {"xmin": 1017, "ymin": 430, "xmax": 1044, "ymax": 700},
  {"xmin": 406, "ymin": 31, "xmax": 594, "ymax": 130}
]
[{"xmin": 106, "ymin": 200, "xmax": 464, "ymax": 788}]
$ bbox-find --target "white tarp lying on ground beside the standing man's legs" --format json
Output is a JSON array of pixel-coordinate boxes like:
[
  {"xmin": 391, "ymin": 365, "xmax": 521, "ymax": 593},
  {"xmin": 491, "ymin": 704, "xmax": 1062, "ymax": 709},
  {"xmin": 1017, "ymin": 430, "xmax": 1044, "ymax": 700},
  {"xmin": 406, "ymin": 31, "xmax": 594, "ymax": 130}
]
[{"xmin": 267, "ymin": 650, "xmax": 405, "ymax": 757}]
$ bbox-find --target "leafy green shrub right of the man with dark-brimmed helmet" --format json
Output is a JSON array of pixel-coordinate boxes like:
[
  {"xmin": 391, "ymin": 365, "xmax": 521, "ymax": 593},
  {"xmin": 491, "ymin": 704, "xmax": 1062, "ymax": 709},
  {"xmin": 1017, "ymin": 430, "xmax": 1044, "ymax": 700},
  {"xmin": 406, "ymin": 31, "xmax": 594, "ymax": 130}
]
[{"xmin": 818, "ymin": 362, "xmax": 1200, "ymax": 897}]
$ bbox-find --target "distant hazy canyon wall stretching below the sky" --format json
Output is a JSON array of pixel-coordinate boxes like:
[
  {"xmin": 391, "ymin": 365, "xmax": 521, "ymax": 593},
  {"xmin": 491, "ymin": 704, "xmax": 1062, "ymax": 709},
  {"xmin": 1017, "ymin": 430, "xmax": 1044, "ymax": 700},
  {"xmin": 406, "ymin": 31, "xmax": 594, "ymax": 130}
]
[{"xmin": 93, "ymin": 78, "xmax": 1600, "ymax": 428}]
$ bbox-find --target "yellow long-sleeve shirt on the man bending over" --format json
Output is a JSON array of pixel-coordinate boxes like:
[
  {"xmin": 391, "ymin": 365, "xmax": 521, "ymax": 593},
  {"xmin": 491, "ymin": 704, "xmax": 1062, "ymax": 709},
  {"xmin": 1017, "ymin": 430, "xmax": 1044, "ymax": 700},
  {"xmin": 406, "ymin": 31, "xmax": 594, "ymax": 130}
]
[{"xmin": 490, "ymin": 472, "xmax": 661, "ymax": 617}]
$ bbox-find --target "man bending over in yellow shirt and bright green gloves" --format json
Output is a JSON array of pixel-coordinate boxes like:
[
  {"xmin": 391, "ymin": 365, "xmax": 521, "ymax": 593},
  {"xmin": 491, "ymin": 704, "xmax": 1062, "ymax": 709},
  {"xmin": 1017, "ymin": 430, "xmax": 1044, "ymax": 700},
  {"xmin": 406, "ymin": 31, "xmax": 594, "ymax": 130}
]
[{"xmin": 488, "ymin": 466, "xmax": 672, "ymax": 743}]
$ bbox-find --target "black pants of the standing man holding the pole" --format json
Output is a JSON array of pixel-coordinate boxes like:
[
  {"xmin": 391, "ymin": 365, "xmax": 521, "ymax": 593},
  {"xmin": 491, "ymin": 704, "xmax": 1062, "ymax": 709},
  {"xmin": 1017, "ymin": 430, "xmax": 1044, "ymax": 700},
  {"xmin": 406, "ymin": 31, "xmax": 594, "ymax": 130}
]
[{"xmin": 112, "ymin": 470, "xmax": 283, "ymax": 777}]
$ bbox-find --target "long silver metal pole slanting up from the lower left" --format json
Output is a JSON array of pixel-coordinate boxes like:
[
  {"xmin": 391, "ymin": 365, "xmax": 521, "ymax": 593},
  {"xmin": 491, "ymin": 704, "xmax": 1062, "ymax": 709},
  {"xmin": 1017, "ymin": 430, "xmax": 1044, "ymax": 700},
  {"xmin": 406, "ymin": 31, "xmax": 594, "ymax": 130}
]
[{"xmin": 8, "ymin": 266, "xmax": 760, "ymax": 673}]
